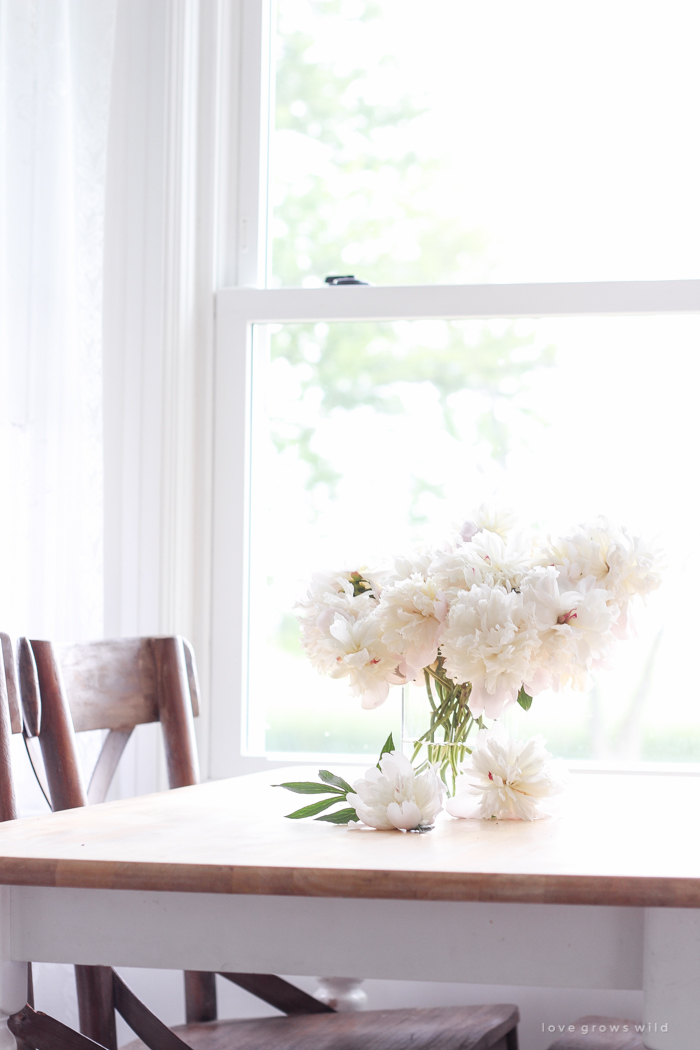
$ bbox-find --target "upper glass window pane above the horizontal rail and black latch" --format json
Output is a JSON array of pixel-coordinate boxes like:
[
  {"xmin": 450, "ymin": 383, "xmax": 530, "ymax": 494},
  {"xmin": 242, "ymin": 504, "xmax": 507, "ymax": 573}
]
[{"xmin": 271, "ymin": 0, "xmax": 700, "ymax": 286}]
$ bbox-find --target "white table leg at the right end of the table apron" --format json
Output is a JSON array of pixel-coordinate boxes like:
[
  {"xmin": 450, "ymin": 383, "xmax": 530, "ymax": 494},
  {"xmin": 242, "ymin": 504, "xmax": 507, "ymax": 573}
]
[{"xmin": 643, "ymin": 908, "xmax": 700, "ymax": 1050}]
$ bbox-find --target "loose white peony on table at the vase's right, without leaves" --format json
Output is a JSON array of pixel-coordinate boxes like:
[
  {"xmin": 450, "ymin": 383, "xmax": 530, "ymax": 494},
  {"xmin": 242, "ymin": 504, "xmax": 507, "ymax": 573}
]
[{"xmin": 446, "ymin": 729, "xmax": 565, "ymax": 820}]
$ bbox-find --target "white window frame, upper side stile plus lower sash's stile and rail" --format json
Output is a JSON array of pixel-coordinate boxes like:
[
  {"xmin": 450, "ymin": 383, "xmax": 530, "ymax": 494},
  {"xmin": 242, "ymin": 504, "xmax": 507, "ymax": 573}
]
[{"xmin": 210, "ymin": 0, "xmax": 700, "ymax": 777}]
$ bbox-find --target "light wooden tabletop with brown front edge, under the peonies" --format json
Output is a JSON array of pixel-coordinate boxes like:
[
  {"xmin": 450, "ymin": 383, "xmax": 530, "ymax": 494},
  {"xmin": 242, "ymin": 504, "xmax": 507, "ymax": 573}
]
[{"xmin": 0, "ymin": 767, "xmax": 700, "ymax": 907}]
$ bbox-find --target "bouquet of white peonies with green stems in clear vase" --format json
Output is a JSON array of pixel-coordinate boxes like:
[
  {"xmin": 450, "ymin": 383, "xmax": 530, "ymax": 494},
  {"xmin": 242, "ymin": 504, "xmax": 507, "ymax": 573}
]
[{"xmin": 296, "ymin": 507, "xmax": 661, "ymax": 786}]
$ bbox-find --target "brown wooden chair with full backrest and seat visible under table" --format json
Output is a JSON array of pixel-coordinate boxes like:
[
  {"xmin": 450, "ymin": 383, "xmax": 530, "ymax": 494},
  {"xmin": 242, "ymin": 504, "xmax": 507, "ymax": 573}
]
[{"xmin": 6, "ymin": 637, "xmax": 519, "ymax": 1050}]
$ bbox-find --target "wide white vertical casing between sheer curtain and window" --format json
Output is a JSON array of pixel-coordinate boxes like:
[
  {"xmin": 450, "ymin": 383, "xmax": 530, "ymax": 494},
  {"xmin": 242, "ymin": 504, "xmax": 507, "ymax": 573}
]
[{"xmin": 104, "ymin": 0, "xmax": 228, "ymax": 793}]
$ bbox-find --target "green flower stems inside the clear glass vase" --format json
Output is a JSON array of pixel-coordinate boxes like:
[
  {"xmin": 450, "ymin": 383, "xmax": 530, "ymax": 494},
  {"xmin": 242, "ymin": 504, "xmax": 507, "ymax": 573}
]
[{"xmin": 411, "ymin": 657, "xmax": 483, "ymax": 794}]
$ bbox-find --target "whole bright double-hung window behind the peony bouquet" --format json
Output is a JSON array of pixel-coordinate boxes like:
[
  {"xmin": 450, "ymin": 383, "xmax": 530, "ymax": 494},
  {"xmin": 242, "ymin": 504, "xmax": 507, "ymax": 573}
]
[{"xmin": 213, "ymin": 0, "xmax": 700, "ymax": 762}]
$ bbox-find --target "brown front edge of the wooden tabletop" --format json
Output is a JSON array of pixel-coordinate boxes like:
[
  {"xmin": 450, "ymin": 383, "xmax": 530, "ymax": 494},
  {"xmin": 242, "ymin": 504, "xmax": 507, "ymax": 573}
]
[{"xmin": 0, "ymin": 857, "xmax": 700, "ymax": 908}]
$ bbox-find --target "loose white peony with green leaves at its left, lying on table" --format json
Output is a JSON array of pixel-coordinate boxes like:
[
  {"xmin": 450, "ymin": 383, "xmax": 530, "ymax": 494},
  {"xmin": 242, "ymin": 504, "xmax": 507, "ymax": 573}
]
[{"xmin": 347, "ymin": 751, "xmax": 445, "ymax": 832}]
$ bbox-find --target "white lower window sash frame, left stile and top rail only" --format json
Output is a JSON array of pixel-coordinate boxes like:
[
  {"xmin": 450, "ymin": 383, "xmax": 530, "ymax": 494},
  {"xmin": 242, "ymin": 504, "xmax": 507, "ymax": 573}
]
[{"xmin": 212, "ymin": 280, "xmax": 700, "ymax": 775}]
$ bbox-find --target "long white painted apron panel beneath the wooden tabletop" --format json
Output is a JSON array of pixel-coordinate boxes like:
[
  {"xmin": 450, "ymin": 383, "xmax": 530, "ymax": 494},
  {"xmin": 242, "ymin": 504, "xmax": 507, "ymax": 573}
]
[{"xmin": 10, "ymin": 886, "xmax": 643, "ymax": 989}]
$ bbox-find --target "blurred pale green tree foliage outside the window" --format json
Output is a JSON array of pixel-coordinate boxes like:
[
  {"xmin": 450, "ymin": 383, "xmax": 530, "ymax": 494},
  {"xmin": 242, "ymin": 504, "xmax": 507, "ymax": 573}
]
[{"xmin": 271, "ymin": 0, "xmax": 555, "ymax": 488}]
